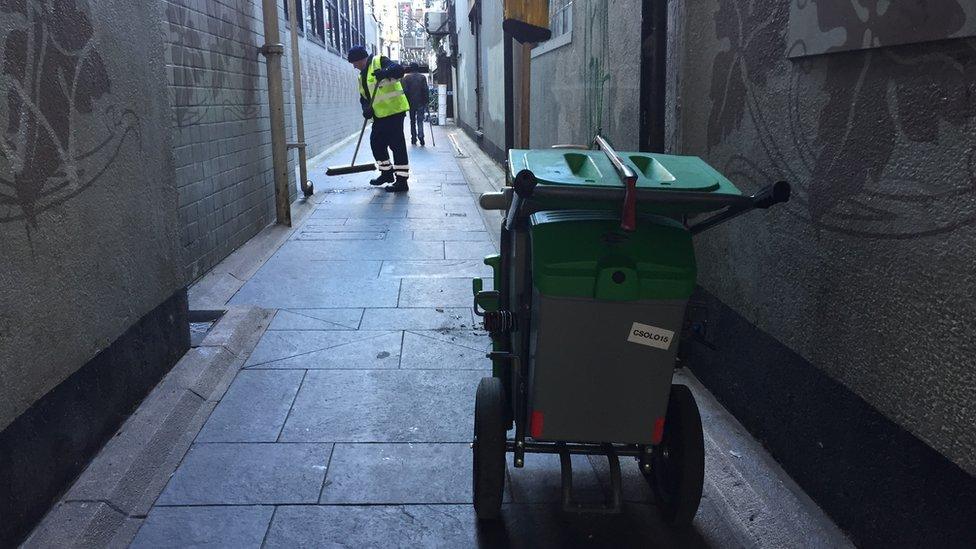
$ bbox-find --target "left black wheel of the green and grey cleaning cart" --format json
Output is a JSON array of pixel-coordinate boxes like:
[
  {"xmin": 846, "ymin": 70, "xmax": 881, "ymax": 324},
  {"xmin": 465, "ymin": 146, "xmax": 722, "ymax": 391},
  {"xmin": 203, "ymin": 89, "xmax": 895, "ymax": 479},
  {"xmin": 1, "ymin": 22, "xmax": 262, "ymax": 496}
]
[{"xmin": 472, "ymin": 377, "xmax": 505, "ymax": 520}]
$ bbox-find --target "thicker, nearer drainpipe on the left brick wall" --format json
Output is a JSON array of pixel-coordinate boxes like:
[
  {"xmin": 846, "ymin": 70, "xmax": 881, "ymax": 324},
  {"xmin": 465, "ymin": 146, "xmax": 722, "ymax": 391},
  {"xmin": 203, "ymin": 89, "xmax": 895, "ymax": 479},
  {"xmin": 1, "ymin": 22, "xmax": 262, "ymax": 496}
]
[{"xmin": 261, "ymin": 0, "xmax": 294, "ymax": 227}]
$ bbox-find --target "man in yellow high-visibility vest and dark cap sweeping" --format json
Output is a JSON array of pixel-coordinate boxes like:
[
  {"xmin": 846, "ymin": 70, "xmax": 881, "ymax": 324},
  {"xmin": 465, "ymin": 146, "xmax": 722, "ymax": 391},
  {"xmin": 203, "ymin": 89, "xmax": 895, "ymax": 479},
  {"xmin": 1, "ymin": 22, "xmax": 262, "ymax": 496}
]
[{"xmin": 347, "ymin": 46, "xmax": 410, "ymax": 192}]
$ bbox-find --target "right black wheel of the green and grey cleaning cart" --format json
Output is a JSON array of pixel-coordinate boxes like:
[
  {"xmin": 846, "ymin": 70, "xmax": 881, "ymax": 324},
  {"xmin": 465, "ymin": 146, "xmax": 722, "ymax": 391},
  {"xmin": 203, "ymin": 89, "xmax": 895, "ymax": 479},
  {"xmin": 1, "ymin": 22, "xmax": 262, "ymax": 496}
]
[{"xmin": 645, "ymin": 385, "xmax": 705, "ymax": 528}]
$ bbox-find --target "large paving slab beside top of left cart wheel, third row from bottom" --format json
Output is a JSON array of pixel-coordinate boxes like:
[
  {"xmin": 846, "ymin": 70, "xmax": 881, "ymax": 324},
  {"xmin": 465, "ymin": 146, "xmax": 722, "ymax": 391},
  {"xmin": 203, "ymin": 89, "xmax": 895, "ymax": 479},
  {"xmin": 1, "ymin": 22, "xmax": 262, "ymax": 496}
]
[{"xmin": 281, "ymin": 370, "xmax": 484, "ymax": 442}]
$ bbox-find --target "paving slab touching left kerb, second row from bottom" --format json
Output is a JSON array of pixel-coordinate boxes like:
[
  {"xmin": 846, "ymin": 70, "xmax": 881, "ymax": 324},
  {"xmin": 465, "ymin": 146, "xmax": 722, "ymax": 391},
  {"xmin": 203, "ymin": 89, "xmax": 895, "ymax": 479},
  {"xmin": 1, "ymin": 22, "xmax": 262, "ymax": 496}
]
[{"xmin": 156, "ymin": 443, "xmax": 332, "ymax": 505}]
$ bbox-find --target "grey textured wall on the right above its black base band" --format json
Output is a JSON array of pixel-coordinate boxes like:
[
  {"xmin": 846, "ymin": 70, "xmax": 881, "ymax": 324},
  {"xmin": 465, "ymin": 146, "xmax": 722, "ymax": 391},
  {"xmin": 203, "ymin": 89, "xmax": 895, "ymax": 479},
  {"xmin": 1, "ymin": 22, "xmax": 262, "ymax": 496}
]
[{"xmin": 673, "ymin": 0, "xmax": 976, "ymax": 474}]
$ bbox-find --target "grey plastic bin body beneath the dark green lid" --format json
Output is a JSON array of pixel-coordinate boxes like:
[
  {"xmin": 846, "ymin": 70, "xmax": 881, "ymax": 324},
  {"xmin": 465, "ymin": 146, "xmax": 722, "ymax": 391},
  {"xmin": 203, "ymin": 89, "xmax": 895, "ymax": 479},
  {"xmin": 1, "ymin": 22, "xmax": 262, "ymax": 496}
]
[{"xmin": 529, "ymin": 291, "xmax": 687, "ymax": 444}]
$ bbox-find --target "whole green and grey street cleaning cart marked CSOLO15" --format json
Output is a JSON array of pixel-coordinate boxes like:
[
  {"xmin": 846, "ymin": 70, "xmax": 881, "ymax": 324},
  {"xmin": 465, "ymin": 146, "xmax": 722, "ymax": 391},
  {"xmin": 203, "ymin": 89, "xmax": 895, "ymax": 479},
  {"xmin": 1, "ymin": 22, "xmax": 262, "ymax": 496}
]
[{"xmin": 472, "ymin": 136, "xmax": 790, "ymax": 526}]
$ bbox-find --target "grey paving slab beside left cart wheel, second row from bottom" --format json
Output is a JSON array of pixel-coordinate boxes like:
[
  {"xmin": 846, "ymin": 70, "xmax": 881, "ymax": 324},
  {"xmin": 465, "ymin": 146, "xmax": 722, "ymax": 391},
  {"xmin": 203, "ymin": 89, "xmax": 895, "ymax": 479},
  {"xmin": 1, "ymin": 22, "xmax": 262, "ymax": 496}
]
[{"xmin": 320, "ymin": 443, "xmax": 473, "ymax": 504}]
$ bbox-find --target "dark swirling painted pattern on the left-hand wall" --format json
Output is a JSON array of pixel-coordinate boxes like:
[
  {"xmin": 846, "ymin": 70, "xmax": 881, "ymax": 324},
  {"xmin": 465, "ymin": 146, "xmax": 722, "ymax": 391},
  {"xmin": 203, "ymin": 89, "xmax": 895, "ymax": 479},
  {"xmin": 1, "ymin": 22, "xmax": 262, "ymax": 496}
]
[{"xmin": 0, "ymin": 0, "xmax": 139, "ymax": 226}]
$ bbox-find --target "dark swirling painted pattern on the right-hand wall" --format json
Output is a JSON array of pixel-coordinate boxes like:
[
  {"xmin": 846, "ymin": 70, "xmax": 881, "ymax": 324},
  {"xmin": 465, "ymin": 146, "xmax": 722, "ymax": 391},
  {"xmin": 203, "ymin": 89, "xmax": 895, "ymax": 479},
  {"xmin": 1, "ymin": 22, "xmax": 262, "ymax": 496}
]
[{"xmin": 707, "ymin": 0, "xmax": 976, "ymax": 238}]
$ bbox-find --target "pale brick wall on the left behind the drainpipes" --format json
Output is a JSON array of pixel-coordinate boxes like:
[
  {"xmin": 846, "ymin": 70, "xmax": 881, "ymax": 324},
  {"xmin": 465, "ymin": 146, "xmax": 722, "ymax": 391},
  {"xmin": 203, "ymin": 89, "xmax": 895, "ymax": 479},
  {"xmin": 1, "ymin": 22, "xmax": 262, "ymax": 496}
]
[{"xmin": 162, "ymin": 0, "xmax": 362, "ymax": 280}]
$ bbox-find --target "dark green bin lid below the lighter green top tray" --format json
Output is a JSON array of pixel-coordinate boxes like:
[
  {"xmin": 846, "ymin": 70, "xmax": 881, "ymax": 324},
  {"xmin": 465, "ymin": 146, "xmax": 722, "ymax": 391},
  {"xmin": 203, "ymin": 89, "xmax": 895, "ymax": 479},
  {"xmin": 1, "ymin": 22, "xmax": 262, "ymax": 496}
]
[{"xmin": 530, "ymin": 210, "xmax": 697, "ymax": 301}]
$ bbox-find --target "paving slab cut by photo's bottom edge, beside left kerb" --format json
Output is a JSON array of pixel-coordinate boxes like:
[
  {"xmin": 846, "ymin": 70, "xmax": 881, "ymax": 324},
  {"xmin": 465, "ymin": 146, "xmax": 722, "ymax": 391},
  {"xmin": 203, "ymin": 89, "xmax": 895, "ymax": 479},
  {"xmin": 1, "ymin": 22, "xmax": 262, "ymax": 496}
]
[{"xmin": 132, "ymin": 506, "xmax": 274, "ymax": 549}]
